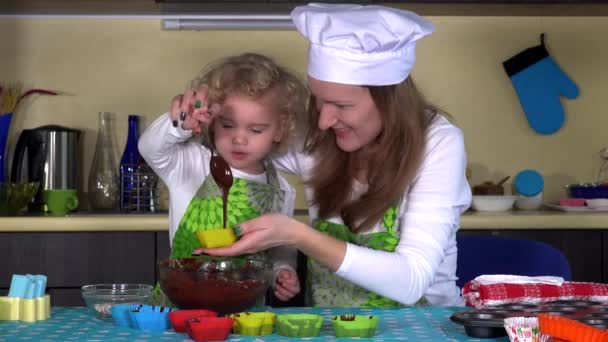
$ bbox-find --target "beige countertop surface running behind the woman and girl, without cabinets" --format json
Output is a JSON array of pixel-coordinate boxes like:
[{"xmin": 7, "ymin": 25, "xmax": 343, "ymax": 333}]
[{"xmin": 0, "ymin": 211, "xmax": 608, "ymax": 232}]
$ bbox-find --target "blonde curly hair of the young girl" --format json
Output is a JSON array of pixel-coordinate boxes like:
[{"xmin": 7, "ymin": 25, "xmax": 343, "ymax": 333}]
[{"xmin": 190, "ymin": 53, "xmax": 308, "ymax": 152}]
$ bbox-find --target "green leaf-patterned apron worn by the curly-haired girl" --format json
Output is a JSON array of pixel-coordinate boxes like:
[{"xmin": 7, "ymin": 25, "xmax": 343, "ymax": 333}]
[{"xmin": 151, "ymin": 162, "xmax": 285, "ymax": 306}]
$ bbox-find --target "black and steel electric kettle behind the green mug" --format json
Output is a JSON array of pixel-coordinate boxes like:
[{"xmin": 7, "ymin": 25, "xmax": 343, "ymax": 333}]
[{"xmin": 11, "ymin": 125, "xmax": 81, "ymax": 210}]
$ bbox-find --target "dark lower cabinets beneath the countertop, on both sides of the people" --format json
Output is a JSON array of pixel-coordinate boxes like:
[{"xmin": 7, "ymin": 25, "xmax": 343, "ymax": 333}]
[{"xmin": 0, "ymin": 229, "xmax": 608, "ymax": 306}]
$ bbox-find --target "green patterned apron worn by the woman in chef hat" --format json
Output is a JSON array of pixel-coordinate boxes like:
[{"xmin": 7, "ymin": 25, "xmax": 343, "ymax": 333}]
[{"xmin": 307, "ymin": 206, "xmax": 426, "ymax": 307}]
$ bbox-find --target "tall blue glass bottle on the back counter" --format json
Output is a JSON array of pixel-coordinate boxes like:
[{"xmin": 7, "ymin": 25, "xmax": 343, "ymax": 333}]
[{"xmin": 120, "ymin": 114, "xmax": 140, "ymax": 211}]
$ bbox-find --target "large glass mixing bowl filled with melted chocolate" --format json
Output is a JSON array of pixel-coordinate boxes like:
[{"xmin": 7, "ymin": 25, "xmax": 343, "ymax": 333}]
[{"xmin": 158, "ymin": 256, "xmax": 272, "ymax": 314}]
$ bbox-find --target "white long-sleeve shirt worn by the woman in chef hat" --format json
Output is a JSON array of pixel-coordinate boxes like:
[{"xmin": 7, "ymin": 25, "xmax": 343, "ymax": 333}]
[{"xmin": 275, "ymin": 116, "xmax": 471, "ymax": 306}]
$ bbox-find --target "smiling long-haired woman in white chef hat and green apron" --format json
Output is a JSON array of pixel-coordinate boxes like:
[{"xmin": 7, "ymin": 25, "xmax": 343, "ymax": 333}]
[{"xmin": 194, "ymin": 4, "xmax": 471, "ymax": 307}]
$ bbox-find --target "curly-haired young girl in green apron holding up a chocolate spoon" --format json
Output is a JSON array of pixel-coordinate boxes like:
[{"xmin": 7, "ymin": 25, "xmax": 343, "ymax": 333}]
[{"xmin": 139, "ymin": 53, "xmax": 306, "ymax": 301}]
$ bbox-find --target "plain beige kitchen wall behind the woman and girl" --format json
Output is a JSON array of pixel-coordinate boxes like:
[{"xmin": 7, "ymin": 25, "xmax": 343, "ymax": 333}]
[{"xmin": 0, "ymin": 16, "xmax": 608, "ymax": 208}]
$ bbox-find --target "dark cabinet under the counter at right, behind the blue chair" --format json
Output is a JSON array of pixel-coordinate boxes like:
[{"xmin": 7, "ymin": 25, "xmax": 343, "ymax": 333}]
[{"xmin": 458, "ymin": 229, "xmax": 608, "ymax": 282}]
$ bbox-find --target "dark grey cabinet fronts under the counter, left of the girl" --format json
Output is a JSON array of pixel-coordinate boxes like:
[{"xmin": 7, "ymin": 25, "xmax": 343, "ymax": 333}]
[{"xmin": 0, "ymin": 232, "xmax": 156, "ymax": 305}]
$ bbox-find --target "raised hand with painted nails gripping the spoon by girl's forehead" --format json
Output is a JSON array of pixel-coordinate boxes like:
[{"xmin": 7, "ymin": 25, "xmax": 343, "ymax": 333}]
[{"xmin": 170, "ymin": 85, "xmax": 219, "ymax": 135}]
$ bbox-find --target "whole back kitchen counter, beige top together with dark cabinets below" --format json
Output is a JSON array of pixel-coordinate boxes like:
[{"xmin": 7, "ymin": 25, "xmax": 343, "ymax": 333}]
[{"xmin": 0, "ymin": 211, "xmax": 608, "ymax": 306}]
